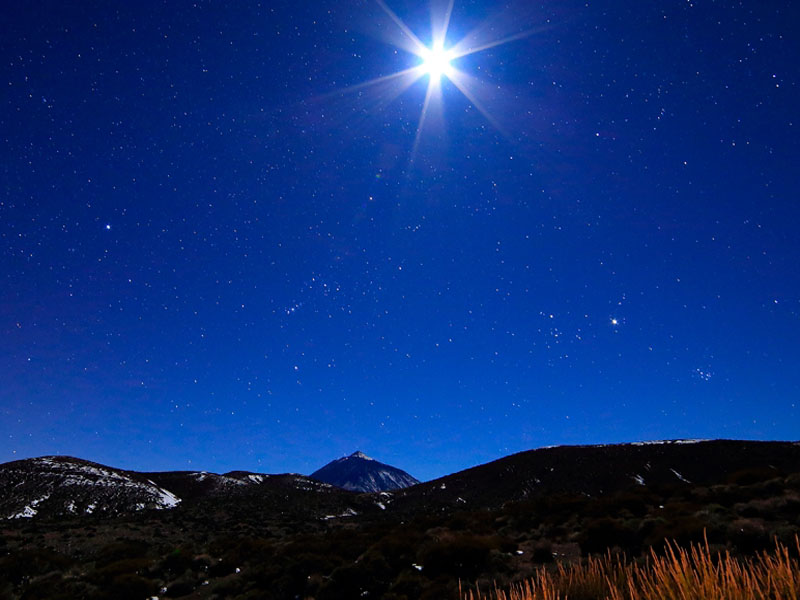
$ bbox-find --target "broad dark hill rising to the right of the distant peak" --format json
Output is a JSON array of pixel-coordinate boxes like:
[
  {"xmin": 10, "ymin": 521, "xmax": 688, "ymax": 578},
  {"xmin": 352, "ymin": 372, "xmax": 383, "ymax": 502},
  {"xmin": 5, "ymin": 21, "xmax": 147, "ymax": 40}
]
[{"xmin": 393, "ymin": 440, "xmax": 800, "ymax": 511}]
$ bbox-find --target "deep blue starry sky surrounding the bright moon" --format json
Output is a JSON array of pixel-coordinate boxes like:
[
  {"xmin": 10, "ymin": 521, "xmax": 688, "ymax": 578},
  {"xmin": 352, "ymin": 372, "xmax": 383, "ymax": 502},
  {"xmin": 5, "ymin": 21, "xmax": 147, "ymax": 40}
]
[{"xmin": 0, "ymin": 0, "xmax": 800, "ymax": 479}]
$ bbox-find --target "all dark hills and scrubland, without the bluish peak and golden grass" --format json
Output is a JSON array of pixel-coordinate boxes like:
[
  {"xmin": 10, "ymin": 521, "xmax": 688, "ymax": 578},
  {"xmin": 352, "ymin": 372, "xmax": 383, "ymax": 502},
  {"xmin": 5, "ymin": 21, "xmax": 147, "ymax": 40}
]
[{"xmin": 0, "ymin": 441, "xmax": 800, "ymax": 600}]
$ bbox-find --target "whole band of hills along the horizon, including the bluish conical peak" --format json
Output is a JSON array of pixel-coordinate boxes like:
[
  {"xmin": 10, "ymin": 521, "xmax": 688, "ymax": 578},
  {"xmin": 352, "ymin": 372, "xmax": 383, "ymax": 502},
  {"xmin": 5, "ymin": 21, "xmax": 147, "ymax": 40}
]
[{"xmin": 0, "ymin": 440, "xmax": 800, "ymax": 523}]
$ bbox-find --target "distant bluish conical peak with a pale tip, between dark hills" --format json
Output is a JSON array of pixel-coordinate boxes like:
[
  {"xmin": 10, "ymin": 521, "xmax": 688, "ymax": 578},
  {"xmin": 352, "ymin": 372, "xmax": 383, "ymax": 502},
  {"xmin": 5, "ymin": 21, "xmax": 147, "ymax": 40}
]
[{"xmin": 310, "ymin": 452, "xmax": 419, "ymax": 492}]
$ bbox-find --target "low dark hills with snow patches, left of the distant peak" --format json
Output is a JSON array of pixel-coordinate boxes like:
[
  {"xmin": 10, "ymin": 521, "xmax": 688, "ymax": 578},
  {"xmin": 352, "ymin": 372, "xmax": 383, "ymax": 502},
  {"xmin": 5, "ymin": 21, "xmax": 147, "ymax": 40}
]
[{"xmin": 0, "ymin": 456, "xmax": 356, "ymax": 521}]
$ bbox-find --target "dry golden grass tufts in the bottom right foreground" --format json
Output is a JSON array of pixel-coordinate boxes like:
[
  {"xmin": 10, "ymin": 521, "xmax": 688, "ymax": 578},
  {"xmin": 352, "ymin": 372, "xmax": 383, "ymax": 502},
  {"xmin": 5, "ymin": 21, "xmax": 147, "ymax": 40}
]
[{"xmin": 462, "ymin": 538, "xmax": 800, "ymax": 600}]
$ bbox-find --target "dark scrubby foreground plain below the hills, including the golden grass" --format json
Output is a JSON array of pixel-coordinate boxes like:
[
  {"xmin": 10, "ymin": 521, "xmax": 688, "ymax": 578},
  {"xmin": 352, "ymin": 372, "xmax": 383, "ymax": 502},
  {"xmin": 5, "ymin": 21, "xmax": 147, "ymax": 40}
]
[{"xmin": 0, "ymin": 468, "xmax": 800, "ymax": 600}]
